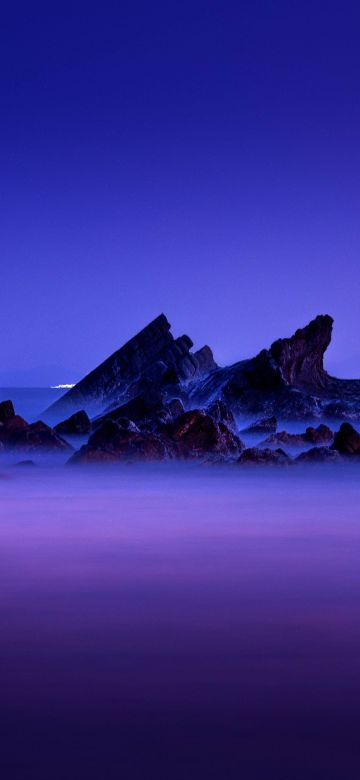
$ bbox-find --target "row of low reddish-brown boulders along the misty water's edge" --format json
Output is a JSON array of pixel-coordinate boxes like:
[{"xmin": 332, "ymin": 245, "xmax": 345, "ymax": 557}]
[{"xmin": 0, "ymin": 394, "xmax": 360, "ymax": 466}]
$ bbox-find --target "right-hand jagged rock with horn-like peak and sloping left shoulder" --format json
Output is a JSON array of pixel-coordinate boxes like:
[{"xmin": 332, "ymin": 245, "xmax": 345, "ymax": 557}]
[{"xmin": 188, "ymin": 315, "xmax": 360, "ymax": 420}]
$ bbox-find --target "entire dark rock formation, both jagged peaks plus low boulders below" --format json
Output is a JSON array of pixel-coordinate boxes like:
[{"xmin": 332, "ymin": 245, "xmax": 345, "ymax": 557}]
[{"xmin": 4, "ymin": 314, "xmax": 360, "ymax": 464}]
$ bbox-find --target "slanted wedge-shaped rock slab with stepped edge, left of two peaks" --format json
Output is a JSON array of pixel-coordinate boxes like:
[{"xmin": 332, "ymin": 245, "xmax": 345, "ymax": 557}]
[{"xmin": 43, "ymin": 314, "xmax": 216, "ymax": 415}]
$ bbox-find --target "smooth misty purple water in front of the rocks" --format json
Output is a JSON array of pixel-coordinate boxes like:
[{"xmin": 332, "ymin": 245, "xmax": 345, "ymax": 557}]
[{"xmin": 0, "ymin": 466, "xmax": 360, "ymax": 780}]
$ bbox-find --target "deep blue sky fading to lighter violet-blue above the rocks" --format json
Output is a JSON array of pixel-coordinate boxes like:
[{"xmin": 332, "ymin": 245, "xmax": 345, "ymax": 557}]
[{"xmin": 0, "ymin": 0, "xmax": 360, "ymax": 382}]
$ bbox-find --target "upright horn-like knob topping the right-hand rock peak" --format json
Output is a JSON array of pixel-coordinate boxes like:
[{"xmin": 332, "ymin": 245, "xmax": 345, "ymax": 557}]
[{"xmin": 269, "ymin": 314, "xmax": 333, "ymax": 387}]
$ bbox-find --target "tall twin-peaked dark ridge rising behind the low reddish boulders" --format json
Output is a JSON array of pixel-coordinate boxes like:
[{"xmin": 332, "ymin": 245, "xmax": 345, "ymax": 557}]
[{"xmin": 47, "ymin": 314, "xmax": 360, "ymax": 427}]
